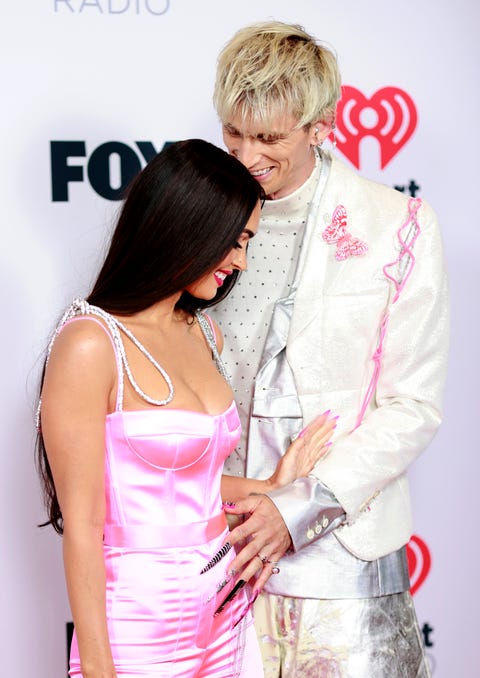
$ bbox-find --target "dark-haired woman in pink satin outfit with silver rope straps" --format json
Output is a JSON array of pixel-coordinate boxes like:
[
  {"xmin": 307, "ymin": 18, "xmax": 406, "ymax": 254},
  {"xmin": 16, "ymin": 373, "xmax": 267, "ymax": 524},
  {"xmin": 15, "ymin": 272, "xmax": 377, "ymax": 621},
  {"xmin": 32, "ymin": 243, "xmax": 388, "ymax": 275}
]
[{"xmin": 37, "ymin": 140, "xmax": 334, "ymax": 678}]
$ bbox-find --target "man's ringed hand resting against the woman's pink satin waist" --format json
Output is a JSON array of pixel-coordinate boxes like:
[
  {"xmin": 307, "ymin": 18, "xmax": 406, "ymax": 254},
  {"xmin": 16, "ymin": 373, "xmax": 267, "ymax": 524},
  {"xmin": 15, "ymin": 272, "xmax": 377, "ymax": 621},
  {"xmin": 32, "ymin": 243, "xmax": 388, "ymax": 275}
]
[{"xmin": 224, "ymin": 494, "xmax": 291, "ymax": 593}]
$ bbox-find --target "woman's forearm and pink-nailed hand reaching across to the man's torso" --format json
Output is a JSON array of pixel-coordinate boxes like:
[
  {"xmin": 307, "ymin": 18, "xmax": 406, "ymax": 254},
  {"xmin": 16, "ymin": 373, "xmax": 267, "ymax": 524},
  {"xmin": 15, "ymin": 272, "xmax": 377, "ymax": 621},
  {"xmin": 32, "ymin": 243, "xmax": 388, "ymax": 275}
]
[{"xmin": 221, "ymin": 412, "xmax": 337, "ymax": 502}]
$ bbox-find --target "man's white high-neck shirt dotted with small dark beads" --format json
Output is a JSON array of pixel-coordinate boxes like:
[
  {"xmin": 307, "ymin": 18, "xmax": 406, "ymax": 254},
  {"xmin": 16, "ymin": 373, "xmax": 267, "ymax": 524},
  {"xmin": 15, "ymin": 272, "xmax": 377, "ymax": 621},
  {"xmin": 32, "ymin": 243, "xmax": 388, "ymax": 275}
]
[{"xmin": 212, "ymin": 156, "xmax": 321, "ymax": 476}]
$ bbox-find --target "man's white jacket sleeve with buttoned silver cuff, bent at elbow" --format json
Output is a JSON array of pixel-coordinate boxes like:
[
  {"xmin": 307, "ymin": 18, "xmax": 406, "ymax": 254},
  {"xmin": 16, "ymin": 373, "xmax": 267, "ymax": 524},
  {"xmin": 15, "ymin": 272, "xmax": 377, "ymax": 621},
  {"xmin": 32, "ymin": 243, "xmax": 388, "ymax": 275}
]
[{"xmin": 271, "ymin": 203, "xmax": 449, "ymax": 550}]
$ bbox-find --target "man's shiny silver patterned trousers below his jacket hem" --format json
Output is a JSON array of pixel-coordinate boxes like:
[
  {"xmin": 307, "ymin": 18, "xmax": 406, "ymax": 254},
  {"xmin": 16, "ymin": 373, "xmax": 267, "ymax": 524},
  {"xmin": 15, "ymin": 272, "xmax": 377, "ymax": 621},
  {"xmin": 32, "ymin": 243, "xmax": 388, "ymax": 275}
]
[{"xmin": 254, "ymin": 592, "xmax": 431, "ymax": 678}]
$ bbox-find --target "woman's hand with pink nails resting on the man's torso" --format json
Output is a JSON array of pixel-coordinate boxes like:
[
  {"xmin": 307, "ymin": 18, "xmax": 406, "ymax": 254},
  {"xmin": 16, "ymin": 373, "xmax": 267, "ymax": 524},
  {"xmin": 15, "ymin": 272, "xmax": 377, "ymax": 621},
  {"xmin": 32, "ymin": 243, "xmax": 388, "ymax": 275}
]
[{"xmin": 267, "ymin": 412, "xmax": 338, "ymax": 490}]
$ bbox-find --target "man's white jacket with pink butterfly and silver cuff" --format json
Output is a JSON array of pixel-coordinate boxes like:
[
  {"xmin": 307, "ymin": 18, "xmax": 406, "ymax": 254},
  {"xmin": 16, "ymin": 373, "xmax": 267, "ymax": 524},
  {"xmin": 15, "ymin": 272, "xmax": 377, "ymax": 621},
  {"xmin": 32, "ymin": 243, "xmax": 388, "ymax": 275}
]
[{"xmin": 266, "ymin": 158, "xmax": 449, "ymax": 560}]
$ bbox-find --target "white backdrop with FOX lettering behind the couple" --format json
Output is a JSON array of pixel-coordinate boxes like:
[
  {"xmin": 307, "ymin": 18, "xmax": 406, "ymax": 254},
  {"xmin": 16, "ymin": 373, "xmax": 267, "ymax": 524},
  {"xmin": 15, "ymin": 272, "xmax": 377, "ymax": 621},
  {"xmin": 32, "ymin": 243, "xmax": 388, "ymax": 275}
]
[{"xmin": 0, "ymin": 0, "xmax": 480, "ymax": 678}]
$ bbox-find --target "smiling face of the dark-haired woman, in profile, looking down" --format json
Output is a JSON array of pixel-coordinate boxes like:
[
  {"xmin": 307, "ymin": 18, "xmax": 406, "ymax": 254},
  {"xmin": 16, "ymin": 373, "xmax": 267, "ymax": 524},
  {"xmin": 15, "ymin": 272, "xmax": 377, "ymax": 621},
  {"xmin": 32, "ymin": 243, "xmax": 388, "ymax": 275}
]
[{"xmin": 186, "ymin": 201, "xmax": 261, "ymax": 299}]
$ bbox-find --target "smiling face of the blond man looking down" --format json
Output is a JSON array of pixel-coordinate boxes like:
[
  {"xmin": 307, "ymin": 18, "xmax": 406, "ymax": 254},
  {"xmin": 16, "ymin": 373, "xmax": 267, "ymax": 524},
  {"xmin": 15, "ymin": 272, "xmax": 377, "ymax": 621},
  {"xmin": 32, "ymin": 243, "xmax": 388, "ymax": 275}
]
[{"xmin": 223, "ymin": 114, "xmax": 318, "ymax": 200}]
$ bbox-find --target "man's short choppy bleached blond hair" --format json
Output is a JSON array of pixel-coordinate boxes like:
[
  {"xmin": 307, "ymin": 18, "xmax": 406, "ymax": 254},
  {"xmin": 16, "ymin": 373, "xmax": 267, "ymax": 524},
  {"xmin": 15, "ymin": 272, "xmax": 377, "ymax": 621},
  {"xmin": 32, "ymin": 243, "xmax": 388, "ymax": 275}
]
[{"xmin": 213, "ymin": 21, "xmax": 341, "ymax": 127}]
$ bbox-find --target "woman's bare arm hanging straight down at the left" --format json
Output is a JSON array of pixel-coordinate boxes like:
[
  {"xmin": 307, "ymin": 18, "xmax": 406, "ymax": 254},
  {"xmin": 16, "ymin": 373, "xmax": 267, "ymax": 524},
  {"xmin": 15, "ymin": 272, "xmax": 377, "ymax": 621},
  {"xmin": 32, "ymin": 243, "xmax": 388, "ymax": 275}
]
[{"xmin": 41, "ymin": 321, "xmax": 116, "ymax": 678}]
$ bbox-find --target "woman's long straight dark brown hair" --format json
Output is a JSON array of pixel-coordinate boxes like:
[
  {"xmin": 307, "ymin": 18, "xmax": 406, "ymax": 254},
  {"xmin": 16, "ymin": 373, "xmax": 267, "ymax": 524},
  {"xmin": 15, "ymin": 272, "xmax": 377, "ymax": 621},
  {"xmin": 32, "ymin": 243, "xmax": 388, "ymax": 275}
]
[{"xmin": 36, "ymin": 139, "xmax": 264, "ymax": 534}]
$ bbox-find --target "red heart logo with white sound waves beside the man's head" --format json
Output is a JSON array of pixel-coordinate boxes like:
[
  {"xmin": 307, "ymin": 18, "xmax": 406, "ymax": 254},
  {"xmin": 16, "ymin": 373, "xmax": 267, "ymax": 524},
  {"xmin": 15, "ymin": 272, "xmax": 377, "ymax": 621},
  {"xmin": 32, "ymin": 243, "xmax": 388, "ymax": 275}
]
[{"xmin": 331, "ymin": 85, "xmax": 417, "ymax": 169}]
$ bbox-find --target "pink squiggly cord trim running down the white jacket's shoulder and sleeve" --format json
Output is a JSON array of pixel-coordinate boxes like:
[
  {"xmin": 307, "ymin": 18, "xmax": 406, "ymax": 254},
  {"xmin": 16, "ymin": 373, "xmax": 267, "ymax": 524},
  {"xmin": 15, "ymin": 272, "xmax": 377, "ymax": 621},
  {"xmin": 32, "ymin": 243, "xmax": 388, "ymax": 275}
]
[{"xmin": 353, "ymin": 198, "xmax": 422, "ymax": 430}]
